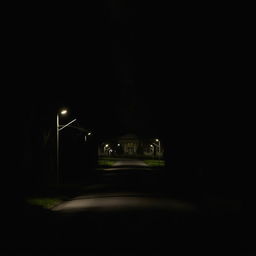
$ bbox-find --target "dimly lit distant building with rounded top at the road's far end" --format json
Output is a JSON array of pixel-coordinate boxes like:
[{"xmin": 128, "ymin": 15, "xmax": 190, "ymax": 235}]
[{"xmin": 98, "ymin": 134, "xmax": 163, "ymax": 158}]
